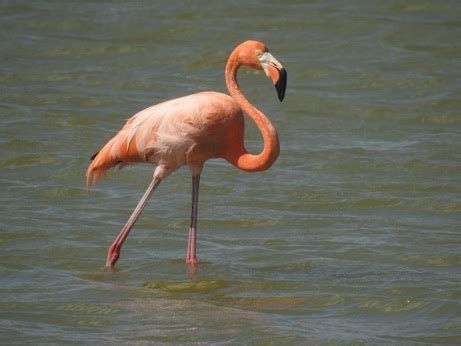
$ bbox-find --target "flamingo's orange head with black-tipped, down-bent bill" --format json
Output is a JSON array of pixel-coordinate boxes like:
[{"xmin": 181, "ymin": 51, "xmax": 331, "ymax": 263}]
[{"xmin": 236, "ymin": 41, "xmax": 287, "ymax": 101}]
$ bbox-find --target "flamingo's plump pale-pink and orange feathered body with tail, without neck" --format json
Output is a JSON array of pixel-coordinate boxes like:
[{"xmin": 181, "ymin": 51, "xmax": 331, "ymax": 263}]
[{"xmin": 87, "ymin": 91, "xmax": 245, "ymax": 182}]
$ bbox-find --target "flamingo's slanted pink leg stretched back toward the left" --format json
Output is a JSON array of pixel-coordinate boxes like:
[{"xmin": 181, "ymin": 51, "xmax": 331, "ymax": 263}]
[{"xmin": 106, "ymin": 178, "xmax": 161, "ymax": 267}]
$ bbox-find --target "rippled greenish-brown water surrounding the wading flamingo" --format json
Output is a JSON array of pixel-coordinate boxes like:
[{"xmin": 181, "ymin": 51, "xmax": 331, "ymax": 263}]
[{"xmin": 0, "ymin": 0, "xmax": 461, "ymax": 345}]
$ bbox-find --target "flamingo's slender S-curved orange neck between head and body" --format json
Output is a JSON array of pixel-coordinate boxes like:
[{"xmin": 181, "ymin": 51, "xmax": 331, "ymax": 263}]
[{"xmin": 226, "ymin": 51, "xmax": 280, "ymax": 172}]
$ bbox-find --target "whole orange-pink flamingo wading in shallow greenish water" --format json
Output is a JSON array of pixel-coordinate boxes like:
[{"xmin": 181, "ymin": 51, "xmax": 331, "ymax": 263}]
[{"xmin": 86, "ymin": 40, "xmax": 287, "ymax": 268}]
